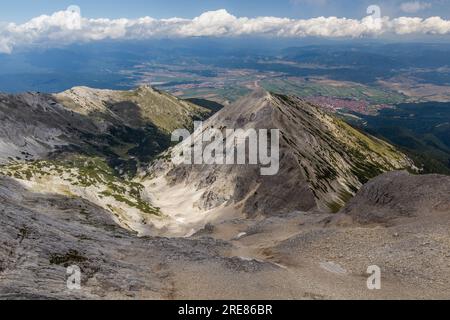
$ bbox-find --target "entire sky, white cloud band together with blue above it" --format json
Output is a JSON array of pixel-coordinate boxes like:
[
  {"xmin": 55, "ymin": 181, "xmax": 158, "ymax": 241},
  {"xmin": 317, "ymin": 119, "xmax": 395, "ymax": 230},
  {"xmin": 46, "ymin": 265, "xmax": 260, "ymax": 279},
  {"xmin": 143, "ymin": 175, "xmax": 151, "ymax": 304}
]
[{"xmin": 0, "ymin": 0, "xmax": 450, "ymax": 54}]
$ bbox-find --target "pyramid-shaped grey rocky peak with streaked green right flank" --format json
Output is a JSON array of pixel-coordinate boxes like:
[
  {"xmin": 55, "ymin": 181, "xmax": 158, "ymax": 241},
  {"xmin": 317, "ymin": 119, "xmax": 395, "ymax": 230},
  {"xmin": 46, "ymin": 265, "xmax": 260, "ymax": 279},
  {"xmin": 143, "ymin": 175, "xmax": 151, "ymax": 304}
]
[{"xmin": 144, "ymin": 90, "xmax": 413, "ymax": 215}]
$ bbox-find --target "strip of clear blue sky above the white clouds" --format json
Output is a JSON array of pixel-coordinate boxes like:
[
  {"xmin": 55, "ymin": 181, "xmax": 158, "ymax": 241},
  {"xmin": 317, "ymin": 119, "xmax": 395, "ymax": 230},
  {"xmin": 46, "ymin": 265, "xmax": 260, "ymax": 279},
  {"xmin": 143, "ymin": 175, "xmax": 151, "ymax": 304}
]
[{"xmin": 0, "ymin": 0, "xmax": 450, "ymax": 23}]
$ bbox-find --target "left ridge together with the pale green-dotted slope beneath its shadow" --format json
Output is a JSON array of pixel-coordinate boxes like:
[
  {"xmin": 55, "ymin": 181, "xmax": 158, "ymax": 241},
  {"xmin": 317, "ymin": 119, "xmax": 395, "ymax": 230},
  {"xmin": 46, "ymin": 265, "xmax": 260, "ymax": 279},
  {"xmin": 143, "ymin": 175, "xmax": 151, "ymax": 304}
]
[{"xmin": 0, "ymin": 86, "xmax": 209, "ymax": 234}]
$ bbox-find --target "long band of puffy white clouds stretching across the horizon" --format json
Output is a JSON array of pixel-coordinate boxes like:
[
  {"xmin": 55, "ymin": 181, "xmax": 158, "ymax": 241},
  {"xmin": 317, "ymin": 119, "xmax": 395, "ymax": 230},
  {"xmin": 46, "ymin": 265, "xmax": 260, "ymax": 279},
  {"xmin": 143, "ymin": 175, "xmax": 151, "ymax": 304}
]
[{"xmin": 0, "ymin": 7, "xmax": 450, "ymax": 53}]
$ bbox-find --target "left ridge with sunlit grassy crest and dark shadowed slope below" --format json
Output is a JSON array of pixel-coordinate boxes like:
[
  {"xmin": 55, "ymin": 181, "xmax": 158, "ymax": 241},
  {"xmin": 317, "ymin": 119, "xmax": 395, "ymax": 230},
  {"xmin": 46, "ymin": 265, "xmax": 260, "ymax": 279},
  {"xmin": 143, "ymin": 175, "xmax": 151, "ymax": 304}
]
[{"xmin": 0, "ymin": 86, "xmax": 209, "ymax": 166}]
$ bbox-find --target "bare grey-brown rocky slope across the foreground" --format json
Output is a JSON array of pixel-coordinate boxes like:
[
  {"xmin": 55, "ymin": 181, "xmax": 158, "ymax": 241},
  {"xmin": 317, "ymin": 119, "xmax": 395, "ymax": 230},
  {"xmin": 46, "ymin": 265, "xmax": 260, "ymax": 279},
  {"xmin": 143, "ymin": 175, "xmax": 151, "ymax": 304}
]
[{"xmin": 0, "ymin": 173, "xmax": 450, "ymax": 300}]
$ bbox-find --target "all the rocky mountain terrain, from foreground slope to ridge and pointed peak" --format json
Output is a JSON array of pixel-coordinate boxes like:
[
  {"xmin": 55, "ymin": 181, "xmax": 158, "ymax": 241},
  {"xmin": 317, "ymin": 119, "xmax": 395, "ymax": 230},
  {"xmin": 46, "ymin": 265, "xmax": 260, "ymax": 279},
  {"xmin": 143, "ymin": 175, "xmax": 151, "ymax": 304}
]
[{"xmin": 0, "ymin": 86, "xmax": 450, "ymax": 299}]
